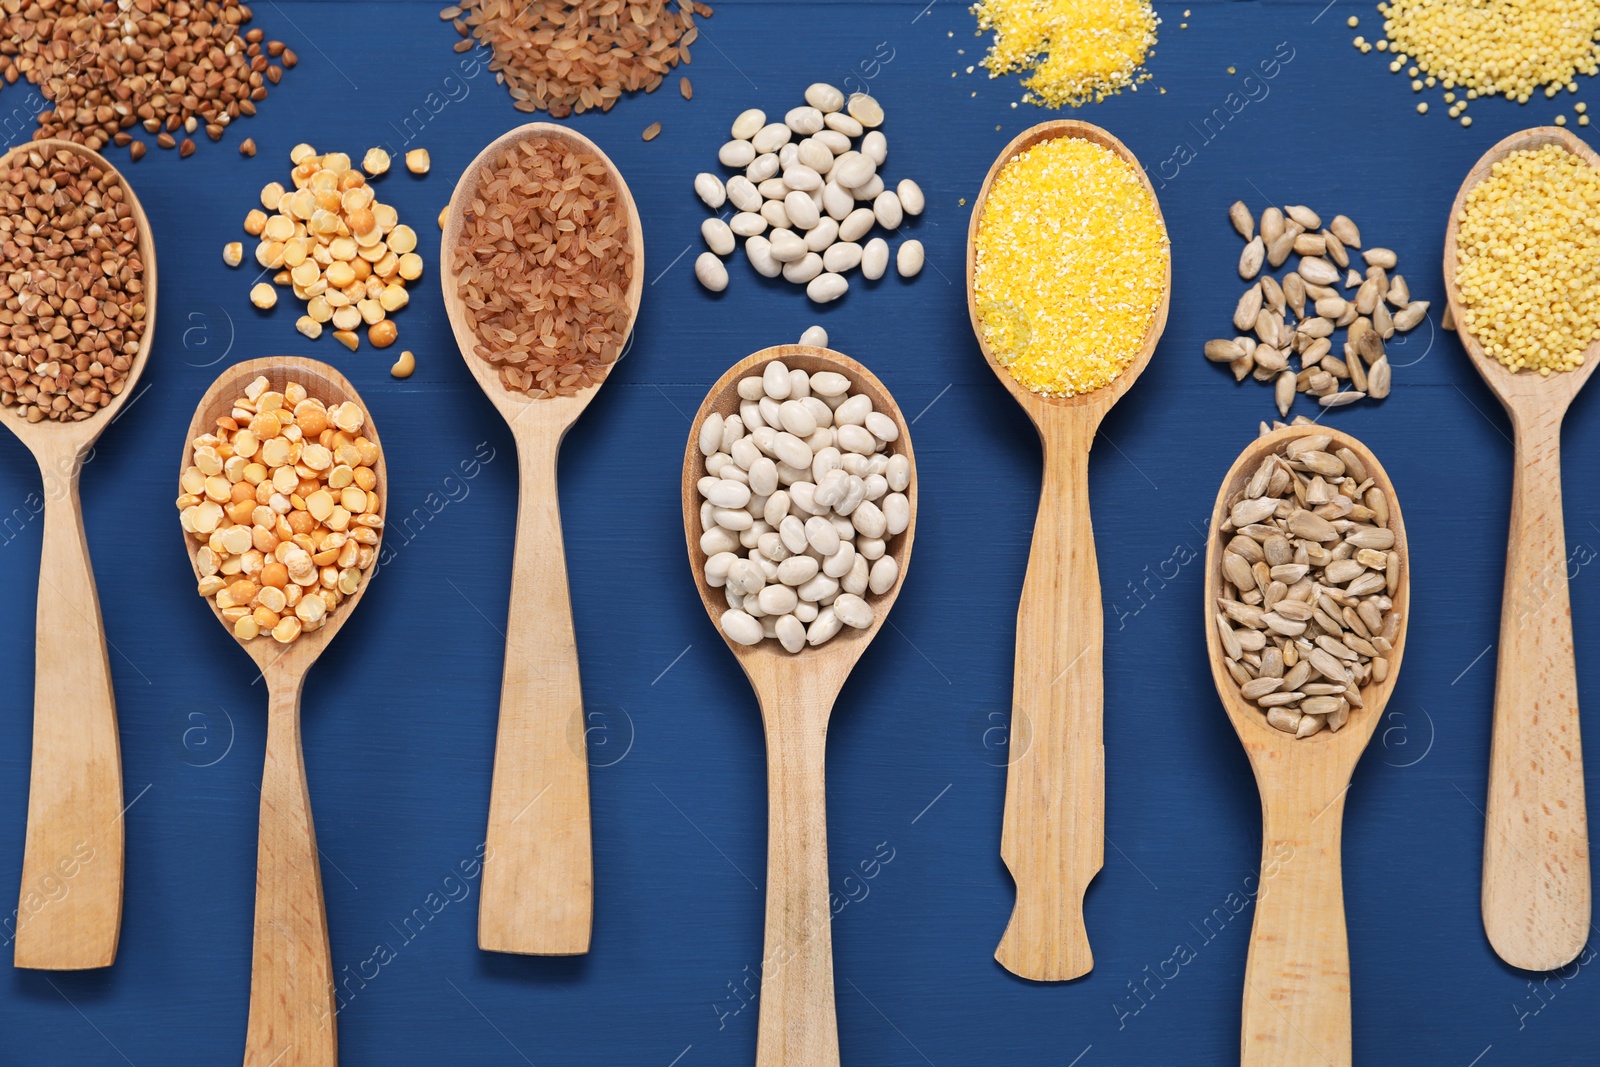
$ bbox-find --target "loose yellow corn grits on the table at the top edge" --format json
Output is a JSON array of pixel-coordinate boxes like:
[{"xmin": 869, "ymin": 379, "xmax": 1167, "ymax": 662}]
[{"xmin": 971, "ymin": 0, "xmax": 1160, "ymax": 107}]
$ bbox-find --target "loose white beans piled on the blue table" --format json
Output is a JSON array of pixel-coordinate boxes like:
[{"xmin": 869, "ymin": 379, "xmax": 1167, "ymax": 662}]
[{"xmin": 694, "ymin": 82, "xmax": 925, "ymax": 304}]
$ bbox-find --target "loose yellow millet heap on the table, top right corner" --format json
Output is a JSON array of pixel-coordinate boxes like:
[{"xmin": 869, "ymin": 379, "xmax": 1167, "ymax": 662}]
[{"xmin": 1378, "ymin": 0, "xmax": 1600, "ymax": 102}]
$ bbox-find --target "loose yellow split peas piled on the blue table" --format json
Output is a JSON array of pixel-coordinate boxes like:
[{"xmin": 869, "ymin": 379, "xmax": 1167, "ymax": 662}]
[{"xmin": 233, "ymin": 144, "xmax": 422, "ymax": 352}]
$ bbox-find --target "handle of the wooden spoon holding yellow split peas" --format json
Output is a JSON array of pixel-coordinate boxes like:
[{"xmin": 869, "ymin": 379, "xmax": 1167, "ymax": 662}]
[{"xmin": 245, "ymin": 667, "xmax": 339, "ymax": 1067}]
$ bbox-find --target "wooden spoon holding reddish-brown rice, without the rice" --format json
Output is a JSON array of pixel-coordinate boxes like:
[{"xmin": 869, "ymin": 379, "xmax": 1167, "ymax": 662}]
[{"xmin": 438, "ymin": 122, "xmax": 645, "ymax": 955}]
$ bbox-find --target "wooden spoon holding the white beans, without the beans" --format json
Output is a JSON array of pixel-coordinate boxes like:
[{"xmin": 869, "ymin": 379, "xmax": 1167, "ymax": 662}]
[{"xmin": 683, "ymin": 344, "xmax": 917, "ymax": 1067}]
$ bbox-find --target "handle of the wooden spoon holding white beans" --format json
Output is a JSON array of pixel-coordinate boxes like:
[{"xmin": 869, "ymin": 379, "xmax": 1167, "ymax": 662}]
[{"xmin": 755, "ymin": 697, "xmax": 838, "ymax": 1067}]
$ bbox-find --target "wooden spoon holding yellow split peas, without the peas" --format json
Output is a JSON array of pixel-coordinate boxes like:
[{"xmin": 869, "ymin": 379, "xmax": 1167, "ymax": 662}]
[{"xmin": 178, "ymin": 355, "xmax": 389, "ymax": 1067}]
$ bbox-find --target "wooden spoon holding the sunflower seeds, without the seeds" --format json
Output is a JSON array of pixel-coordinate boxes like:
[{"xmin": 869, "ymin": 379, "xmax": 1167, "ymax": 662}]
[{"xmin": 1205, "ymin": 426, "xmax": 1411, "ymax": 1067}]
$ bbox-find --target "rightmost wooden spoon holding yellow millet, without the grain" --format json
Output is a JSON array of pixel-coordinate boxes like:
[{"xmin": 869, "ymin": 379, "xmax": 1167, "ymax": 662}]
[{"xmin": 1445, "ymin": 126, "xmax": 1600, "ymax": 971}]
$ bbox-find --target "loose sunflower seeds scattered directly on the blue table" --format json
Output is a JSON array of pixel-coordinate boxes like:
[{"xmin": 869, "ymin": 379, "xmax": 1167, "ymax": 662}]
[{"xmin": 1205, "ymin": 200, "xmax": 1429, "ymax": 416}]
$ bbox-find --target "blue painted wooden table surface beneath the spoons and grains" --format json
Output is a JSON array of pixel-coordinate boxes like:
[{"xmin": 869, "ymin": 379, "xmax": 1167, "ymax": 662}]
[{"xmin": 0, "ymin": 0, "xmax": 1600, "ymax": 1067}]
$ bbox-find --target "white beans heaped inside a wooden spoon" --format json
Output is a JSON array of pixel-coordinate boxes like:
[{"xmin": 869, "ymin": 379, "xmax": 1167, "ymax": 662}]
[{"xmin": 699, "ymin": 360, "xmax": 912, "ymax": 653}]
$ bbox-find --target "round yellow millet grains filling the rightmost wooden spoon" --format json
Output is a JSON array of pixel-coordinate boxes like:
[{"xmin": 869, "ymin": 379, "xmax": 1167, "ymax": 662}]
[{"xmin": 1456, "ymin": 144, "xmax": 1600, "ymax": 374}]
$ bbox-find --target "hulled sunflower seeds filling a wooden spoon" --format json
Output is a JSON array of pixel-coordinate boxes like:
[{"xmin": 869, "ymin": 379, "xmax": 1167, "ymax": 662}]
[{"xmin": 1216, "ymin": 434, "xmax": 1405, "ymax": 737}]
